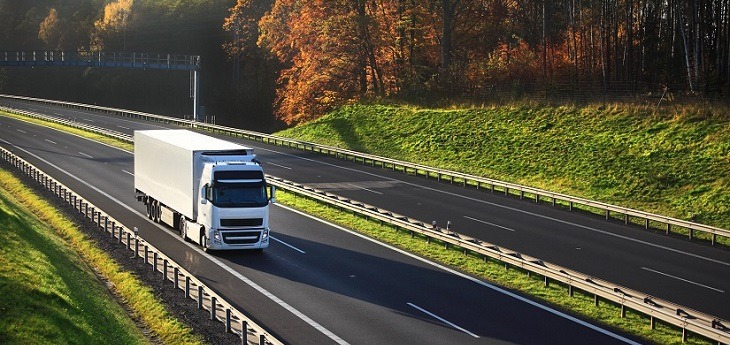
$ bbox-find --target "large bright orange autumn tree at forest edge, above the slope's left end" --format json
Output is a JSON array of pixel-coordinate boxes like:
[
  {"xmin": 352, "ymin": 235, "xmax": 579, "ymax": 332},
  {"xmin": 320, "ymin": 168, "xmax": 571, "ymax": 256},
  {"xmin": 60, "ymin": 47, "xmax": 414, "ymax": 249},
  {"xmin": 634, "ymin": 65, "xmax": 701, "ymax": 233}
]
[{"xmin": 259, "ymin": 0, "xmax": 384, "ymax": 123}]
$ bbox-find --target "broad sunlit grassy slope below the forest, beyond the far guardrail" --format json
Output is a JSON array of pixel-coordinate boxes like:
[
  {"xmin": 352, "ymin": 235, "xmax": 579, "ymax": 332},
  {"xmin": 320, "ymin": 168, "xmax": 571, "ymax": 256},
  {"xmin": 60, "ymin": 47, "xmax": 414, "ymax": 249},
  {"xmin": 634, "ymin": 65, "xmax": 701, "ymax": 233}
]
[{"xmin": 276, "ymin": 105, "xmax": 730, "ymax": 228}]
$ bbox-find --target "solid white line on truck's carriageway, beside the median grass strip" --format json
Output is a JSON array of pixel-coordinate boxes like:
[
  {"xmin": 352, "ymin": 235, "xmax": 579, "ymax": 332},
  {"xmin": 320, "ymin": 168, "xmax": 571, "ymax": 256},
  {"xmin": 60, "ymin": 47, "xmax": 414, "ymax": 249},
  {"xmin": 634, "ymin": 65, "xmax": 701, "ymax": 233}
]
[{"xmin": 274, "ymin": 204, "xmax": 641, "ymax": 345}]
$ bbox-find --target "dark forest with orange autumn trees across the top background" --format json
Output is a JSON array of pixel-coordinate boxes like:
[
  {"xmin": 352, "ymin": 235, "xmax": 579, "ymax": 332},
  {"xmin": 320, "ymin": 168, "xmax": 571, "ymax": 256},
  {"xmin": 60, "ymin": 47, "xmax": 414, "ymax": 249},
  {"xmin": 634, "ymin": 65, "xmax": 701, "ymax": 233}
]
[{"xmin": 0, "ymin": 0, "xmax": 730, "ymax": 130}]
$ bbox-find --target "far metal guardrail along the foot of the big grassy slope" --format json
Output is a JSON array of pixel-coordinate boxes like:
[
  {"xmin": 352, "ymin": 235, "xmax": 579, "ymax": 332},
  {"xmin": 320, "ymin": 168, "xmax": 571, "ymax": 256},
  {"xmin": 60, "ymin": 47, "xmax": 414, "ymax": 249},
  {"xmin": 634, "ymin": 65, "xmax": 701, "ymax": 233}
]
[{"xmin": 0, "ymin": 94, "xmax": 730, "ymax": 245}]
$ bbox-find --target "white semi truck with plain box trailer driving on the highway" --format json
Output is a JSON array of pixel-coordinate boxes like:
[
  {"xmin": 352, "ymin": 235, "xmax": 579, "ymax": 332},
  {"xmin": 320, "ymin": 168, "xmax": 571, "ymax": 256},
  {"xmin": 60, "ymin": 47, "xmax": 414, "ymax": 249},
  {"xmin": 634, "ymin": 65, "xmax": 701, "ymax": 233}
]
[{"xmin": 134, "ymin": 130, "xmax": 274, "ymax": 251}]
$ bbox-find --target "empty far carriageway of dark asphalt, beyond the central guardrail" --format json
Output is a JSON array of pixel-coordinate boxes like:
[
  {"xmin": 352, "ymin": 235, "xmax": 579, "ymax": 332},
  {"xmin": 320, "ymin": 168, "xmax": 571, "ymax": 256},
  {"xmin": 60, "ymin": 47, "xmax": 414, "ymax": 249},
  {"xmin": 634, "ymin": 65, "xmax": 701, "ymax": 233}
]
[{"xmin": 8, "ymin": 97, "xmax": 730, "ymax": 319}]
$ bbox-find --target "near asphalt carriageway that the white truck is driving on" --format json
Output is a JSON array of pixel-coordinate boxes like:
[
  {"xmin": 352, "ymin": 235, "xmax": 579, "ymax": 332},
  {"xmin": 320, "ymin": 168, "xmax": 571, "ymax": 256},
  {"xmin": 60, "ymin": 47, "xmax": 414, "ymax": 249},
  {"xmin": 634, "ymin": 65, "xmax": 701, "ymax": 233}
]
[{"xmin": 0, "ymin": 109, "xmax": 636, "ymax": 344}]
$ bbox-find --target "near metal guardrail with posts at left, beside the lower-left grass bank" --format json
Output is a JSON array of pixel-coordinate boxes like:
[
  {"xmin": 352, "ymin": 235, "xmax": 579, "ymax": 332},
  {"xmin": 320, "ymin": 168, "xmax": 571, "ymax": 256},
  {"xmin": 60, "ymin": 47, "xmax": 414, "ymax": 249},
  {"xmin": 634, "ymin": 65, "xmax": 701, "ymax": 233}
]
[{"xmin": 0, "ymin": 147, "xmax": 283, "ymax": 345}]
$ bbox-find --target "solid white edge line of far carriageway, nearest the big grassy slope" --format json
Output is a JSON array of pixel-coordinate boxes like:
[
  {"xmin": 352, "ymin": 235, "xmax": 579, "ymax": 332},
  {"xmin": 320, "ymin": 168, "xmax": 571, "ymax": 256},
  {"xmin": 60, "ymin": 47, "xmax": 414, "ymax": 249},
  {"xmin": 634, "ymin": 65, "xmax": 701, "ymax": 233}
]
[{"xmin": 258, "ymin": 147, "xmax": 730, "ymax": 266}]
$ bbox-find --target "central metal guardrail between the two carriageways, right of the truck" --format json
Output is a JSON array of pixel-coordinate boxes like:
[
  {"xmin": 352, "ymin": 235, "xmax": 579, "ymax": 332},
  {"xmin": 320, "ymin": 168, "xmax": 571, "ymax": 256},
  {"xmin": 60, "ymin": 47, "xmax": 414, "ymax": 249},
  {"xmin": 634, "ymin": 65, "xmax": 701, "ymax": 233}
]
[{"xmin": 267, "ymin": 175, "xmax": 730, "ymax": 344}]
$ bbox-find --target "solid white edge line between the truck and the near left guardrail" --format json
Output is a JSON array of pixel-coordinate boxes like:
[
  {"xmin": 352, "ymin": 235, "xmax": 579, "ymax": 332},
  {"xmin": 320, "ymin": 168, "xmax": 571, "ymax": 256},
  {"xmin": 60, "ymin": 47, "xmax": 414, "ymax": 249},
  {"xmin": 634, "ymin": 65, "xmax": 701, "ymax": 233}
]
[{"xmin": 0, "ymin": 139, "xmax": 349, "ymax": 345}]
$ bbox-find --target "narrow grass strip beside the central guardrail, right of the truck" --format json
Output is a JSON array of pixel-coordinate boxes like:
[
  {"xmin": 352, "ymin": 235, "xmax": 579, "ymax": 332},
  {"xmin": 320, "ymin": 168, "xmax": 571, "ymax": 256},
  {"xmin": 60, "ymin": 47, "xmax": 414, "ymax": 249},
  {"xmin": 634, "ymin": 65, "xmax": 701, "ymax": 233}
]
[{"xmin": 277, "ymin": 189, "xmax": 712, "ymax": 344}]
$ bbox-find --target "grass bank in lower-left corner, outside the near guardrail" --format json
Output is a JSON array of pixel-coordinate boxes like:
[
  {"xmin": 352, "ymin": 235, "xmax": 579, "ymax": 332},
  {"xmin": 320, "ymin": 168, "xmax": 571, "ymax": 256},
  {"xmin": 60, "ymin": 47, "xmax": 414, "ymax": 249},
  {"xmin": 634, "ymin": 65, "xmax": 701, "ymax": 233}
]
[{"xmin": 0, "ymin": 170, "xmax": 201, "ymax": 344}]
